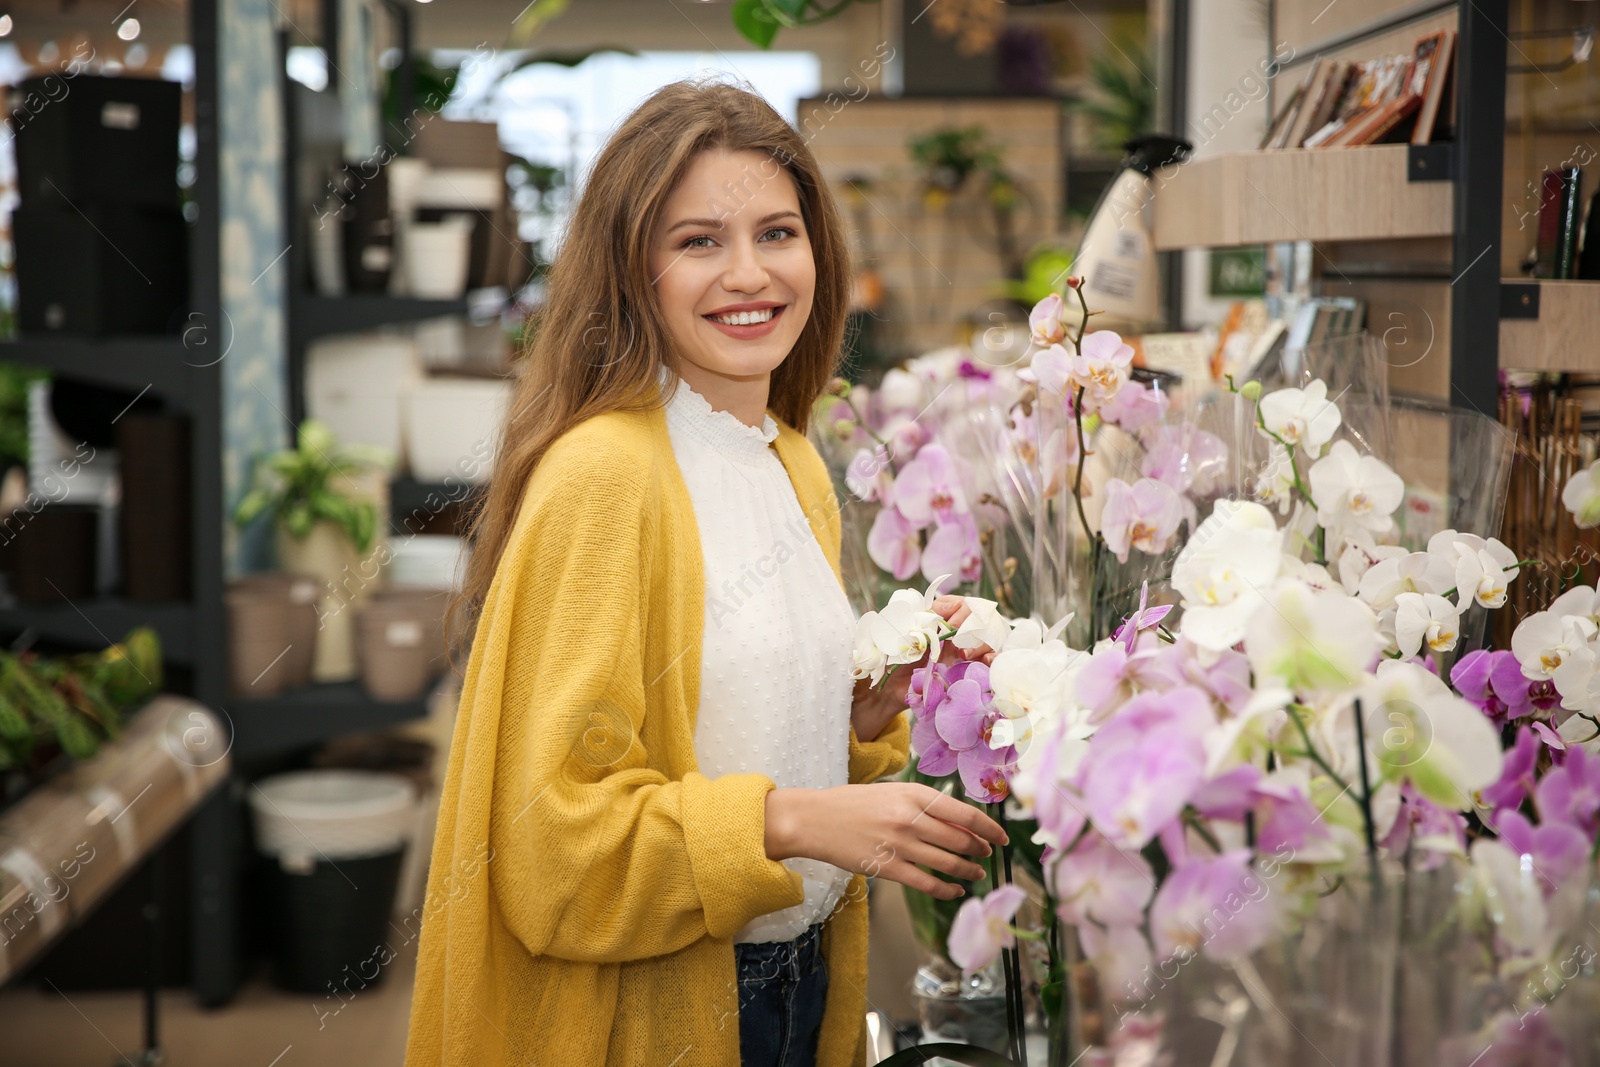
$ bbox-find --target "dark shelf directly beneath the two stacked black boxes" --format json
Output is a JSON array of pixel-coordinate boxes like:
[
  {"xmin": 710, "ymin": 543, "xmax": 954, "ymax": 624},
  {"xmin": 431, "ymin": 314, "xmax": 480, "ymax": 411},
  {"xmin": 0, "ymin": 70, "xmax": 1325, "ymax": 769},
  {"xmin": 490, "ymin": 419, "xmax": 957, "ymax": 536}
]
[{"xmin": 0, "ymin": 336, "xmax": 201, "ymax": 405}]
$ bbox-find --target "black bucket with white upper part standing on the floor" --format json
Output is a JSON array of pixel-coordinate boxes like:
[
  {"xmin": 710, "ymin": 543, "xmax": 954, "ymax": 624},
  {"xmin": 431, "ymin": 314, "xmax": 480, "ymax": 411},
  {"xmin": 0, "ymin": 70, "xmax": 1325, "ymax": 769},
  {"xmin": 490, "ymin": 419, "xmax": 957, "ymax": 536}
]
[{"xmin": 250, "ymin": 769, "xmax": 416, "ymax": 1000}]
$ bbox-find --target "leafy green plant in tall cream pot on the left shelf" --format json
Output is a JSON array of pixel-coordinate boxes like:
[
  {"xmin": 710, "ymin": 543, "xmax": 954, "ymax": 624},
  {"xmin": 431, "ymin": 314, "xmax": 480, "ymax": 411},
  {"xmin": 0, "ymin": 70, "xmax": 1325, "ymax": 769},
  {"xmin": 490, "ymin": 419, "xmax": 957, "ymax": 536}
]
[{"xmin": 234, "ymin": 419, "xmax": 394, "ymax": 681}]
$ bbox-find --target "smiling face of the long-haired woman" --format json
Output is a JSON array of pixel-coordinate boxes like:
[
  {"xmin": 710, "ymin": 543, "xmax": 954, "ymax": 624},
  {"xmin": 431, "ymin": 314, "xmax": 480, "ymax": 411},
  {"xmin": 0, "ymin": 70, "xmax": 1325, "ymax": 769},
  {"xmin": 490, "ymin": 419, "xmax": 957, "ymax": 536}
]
[{"xmin": 650, "ymin": 149, "xmax": 816, "ymax": 394}]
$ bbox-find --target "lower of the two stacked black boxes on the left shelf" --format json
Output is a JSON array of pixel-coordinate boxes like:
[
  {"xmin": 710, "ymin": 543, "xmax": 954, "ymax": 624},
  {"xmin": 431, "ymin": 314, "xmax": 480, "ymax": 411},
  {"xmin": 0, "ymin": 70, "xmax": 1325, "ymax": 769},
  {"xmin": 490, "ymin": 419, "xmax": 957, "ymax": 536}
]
[{"xmin": 11, "ymin": 205, "xmax": 189, "ymax": 336}]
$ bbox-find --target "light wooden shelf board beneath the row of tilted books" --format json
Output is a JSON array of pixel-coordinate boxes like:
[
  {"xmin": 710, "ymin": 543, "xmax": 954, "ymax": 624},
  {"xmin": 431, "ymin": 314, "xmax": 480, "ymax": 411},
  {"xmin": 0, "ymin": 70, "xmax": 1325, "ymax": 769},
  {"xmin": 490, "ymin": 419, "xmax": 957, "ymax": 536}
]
[{"xmin": 1152, "ymin": 144, "xmax": 1454, "ymax": 250}]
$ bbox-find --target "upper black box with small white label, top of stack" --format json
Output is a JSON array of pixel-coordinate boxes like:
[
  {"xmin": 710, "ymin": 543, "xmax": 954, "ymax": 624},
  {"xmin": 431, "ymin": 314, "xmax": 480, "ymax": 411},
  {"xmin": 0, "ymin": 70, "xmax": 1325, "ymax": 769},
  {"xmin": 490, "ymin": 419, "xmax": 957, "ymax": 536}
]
[{"xmin": 11, "ymin": 74, "xmax": 184, "ymax": 210}]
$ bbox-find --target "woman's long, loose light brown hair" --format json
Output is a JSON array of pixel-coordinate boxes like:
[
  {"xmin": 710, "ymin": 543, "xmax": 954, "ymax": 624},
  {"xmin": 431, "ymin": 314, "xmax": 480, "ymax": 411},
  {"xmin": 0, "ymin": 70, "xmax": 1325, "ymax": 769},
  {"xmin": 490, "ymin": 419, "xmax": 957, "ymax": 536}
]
[{"xmin": 446, "ymin": 82, "xmax": 851, "ymax": 662}]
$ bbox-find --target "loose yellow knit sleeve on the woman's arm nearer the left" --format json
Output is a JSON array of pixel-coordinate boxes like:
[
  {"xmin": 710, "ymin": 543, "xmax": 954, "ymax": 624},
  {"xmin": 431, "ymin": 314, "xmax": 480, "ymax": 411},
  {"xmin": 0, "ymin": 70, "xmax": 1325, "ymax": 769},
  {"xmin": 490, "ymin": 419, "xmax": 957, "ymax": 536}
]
[{"xmin": 456, "ymin": 428, "xmax": 805, "ymax": 963}]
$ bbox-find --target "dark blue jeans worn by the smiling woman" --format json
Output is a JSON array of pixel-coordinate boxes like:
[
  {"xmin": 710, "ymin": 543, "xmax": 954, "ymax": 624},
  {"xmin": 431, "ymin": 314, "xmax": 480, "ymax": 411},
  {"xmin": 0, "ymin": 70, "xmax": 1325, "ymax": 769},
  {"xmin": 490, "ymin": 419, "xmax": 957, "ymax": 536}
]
[{"xmin": 733, "ymin": 923, "xmax": 827, "ymax": 1067}]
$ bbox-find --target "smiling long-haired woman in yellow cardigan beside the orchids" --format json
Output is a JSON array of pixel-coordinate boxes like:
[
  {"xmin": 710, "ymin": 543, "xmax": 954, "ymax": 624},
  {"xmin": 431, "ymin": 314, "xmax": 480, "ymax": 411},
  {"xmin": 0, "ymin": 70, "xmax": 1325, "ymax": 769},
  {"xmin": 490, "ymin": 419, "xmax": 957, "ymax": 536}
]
[{"xmin": 406, "ymin": 83, "xmax": 1005, "ymax": 1067}]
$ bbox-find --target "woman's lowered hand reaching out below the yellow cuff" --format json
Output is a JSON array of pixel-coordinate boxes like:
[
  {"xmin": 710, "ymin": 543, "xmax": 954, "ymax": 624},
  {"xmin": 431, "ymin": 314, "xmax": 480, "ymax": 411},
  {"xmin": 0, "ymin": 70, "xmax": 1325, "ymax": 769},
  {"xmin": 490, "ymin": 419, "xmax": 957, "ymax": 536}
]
[{"xmin": 766, "ymin": 782, "xmax": 1006, "ymax": 901}]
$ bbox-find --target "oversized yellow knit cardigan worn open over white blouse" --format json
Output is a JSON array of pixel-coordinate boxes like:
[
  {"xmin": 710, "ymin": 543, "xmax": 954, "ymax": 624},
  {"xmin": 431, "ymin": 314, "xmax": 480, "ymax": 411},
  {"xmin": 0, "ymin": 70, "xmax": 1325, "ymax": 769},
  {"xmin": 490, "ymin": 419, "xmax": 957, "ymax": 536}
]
[{"xmin": 406, "ymin": 408, "xmax": 910, "ymax": 1067}]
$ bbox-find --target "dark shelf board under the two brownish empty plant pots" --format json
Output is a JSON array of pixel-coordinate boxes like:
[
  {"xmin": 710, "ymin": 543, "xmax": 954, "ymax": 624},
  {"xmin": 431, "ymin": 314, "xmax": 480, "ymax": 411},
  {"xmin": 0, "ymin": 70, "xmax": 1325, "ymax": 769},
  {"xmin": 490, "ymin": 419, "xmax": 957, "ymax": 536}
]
[{"xmin": 222, "ymin": 681, "xmax": 434, "ymax": 758}]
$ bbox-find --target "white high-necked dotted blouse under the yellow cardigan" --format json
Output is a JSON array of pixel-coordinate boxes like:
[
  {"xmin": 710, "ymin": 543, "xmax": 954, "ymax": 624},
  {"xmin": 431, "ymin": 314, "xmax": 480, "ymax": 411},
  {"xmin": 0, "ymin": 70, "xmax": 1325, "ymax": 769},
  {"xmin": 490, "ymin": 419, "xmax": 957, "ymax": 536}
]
[{"xmin": 667, "ymin": 381, "xmax": 856, "ymax": 941}]
